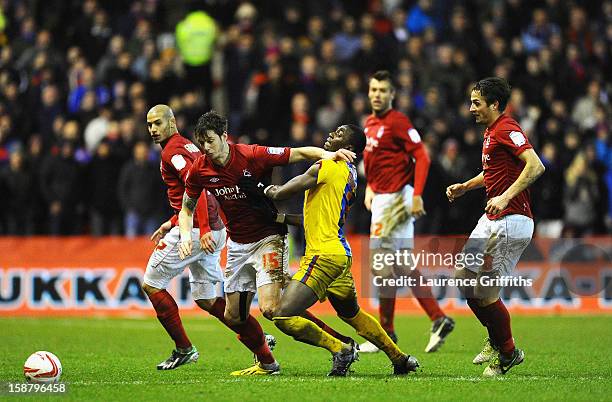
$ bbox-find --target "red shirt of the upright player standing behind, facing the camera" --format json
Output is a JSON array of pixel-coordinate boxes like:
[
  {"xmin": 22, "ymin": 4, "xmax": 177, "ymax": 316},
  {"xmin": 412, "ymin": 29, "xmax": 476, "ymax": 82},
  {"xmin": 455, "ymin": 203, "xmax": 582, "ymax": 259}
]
[{"xmin": 363, "ymin": 109, "xmax": 427, "ymax": 195}]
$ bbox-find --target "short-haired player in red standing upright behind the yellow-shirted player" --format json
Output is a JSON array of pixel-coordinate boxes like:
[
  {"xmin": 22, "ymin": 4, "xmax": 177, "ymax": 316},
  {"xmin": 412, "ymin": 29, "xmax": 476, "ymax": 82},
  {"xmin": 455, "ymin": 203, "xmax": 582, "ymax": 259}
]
[{"xmin": 360, "ymin": 71, "xmax": 455, "ymax": 353}]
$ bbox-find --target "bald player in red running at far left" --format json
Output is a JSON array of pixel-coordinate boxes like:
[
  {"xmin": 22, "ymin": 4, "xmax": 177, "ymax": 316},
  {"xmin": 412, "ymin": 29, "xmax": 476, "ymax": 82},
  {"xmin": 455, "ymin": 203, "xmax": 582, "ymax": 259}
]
[{"xmin": 142, "ymin": 105, "xmax": 274, "ymax": 370}]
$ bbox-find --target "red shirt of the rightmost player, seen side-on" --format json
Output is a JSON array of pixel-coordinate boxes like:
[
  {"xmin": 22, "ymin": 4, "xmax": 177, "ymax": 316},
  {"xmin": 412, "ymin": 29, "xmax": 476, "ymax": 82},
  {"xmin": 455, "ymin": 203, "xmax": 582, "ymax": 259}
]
[{"xmin": 482, "ymin": 114, "xmax": 533, "ymax": 220}]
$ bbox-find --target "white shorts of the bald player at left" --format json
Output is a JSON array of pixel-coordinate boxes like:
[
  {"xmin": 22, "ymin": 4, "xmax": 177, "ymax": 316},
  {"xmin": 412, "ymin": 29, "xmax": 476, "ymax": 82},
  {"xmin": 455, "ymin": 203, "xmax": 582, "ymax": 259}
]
[{"xmin": 144, "ymin": 226, "xmax": 226, "ymax": 300}]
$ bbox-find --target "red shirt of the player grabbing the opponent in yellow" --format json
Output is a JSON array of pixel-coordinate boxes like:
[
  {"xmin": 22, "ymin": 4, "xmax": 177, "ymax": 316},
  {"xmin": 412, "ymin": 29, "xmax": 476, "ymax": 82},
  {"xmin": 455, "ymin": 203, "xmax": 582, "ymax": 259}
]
[{"xmin": 186, "ymin": 144, "xmax": 291, "ymax": 243}]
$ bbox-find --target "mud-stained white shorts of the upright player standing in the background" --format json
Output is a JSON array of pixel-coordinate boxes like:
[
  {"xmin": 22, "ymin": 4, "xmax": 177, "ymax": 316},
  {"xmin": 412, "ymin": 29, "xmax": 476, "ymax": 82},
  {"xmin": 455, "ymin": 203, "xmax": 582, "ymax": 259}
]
[{"xmin": 370, "ymin": 184, "xmax": 414, "ymax": 250}]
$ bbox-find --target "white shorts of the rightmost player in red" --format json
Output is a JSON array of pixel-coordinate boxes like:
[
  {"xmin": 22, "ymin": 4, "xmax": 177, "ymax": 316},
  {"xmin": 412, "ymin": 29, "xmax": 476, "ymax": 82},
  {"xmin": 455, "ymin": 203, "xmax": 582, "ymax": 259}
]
[{"xmin": 456, "ymin": 214, "xmax": 533, "ymax": 276}]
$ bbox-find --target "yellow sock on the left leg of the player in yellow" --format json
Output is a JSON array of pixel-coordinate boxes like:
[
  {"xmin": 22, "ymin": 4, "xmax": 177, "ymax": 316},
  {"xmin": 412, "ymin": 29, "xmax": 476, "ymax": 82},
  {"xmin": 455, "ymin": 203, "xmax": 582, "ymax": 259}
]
[{"xmin": 272, "ymin": 316, "xmax": 345, "ymax": 353}]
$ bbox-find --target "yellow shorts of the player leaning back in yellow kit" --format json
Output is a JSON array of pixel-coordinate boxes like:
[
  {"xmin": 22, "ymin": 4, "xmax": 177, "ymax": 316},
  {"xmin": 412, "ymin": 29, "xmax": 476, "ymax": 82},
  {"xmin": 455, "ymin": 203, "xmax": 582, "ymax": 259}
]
[{"xmin": 292, "ymin": 254, "xmax": 357, "ymax": 302}]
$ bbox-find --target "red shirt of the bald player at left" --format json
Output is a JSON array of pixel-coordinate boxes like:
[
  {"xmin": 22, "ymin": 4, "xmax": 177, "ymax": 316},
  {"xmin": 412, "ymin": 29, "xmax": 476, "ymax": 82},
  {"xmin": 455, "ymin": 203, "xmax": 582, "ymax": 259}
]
[{"xmin": 159, "ymin": 133, "xmax": 223, "ymax": 230}]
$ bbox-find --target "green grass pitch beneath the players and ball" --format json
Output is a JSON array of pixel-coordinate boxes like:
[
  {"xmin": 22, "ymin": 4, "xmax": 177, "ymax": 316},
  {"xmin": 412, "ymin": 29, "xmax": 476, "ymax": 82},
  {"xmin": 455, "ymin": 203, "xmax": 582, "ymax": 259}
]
[{"xmin": 0, "ymin": 314, "xmax": 612, "ymax": 402}]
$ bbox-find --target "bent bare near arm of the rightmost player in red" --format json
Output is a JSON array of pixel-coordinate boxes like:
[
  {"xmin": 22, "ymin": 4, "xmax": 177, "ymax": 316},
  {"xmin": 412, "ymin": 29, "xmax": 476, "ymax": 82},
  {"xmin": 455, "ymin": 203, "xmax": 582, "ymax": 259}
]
[{"xmin": 485, "ymin": 149, "xmax": 545, "ymax": 214}]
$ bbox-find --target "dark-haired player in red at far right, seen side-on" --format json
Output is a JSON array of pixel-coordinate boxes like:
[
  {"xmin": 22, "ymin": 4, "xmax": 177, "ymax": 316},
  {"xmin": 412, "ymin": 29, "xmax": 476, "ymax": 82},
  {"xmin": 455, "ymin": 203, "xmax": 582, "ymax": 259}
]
[{"xmin": 446, "ymin": 77, "xmax": 544, "ymax": 377}]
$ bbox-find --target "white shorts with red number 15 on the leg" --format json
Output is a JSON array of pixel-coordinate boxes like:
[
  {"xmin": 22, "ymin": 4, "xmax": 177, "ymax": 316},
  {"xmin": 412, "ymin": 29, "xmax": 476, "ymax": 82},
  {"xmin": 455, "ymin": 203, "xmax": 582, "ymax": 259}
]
[{"xmin": 223, "ymin": 235, "xmax": 289, "ymax": 293}]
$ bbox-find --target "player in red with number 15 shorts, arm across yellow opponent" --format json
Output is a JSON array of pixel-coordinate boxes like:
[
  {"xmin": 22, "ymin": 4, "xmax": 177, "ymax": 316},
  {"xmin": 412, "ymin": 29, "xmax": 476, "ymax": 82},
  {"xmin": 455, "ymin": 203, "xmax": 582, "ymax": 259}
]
[{"xmin": 179, "ymin": 111, "xmax": 357, "ymax": 375}]
